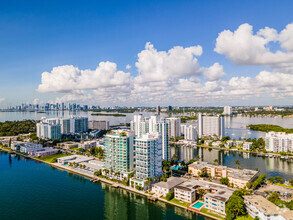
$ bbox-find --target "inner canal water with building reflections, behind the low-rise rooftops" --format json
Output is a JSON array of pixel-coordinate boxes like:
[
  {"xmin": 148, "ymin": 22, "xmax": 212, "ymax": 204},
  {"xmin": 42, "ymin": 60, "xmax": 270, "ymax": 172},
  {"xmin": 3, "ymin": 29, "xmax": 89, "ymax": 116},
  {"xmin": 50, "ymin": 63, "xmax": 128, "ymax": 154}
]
[{"xmin": 170, "ymin": 145, "xmax": 293, "ymax": 180}]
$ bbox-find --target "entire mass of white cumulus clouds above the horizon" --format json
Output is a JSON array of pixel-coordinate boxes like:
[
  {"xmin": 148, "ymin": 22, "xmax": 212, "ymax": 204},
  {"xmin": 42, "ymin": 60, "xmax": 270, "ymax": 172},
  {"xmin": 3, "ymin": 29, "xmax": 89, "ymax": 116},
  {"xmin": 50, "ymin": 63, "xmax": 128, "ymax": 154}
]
[{"xmin": 37, "ymin": 23, "xmax": 293, "ymax": 105}]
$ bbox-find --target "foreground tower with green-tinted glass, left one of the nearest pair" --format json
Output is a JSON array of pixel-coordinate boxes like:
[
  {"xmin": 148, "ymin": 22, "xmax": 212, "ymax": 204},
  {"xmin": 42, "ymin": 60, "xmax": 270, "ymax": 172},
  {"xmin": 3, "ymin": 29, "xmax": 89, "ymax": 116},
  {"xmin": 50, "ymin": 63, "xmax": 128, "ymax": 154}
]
[{"xmin": 105, "ymin": 129, "xmax": 134, "ymax": 173}]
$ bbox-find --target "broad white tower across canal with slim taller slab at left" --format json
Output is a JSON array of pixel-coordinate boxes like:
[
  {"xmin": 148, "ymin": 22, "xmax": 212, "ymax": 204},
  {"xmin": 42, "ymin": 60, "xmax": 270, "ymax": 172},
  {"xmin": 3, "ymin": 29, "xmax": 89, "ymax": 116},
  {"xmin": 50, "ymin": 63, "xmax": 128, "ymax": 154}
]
[{"xmin": 197, "ymin": 113, "xmax": 224, "ymax": 138}]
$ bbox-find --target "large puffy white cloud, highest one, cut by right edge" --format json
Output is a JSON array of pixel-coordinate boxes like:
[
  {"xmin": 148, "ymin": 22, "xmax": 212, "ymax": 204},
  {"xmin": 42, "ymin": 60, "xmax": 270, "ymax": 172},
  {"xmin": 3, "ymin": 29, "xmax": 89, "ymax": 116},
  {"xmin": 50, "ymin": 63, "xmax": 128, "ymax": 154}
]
[{"xmin": 214, "ymin": 23, "xmax": 293, "ymax": 71}]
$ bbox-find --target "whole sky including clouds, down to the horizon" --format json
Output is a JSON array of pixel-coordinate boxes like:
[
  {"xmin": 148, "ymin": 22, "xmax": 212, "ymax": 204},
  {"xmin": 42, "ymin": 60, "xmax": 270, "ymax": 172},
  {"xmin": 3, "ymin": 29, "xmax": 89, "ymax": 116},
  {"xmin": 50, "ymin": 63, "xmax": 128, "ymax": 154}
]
[{"xmin": 0, "ymin": 0, "xmax": 293, "ymax": 108}]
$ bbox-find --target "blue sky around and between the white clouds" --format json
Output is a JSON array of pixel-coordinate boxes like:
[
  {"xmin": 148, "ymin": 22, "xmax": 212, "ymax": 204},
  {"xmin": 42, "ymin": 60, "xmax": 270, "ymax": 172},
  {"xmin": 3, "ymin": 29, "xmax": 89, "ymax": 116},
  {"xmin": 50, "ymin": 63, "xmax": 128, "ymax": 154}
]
[{"xmin": 0, "ymin": 0, "xmax": 293, "ymax": 107}]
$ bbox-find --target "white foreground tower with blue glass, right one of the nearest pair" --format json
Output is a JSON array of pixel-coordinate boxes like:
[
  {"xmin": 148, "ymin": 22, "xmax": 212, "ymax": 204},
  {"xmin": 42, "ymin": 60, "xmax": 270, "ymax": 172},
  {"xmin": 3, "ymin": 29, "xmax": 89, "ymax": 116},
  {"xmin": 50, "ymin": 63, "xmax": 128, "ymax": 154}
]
[{"xmin": 134, "ymin": 133, "xmax": 162, "ymax": 179}]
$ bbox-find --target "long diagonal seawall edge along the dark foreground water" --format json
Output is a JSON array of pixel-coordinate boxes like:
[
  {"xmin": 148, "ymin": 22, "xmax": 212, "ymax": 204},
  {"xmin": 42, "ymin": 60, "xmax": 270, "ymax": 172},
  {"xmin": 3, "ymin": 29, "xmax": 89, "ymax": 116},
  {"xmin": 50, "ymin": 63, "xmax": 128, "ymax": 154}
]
[{"xmin": 0, "ymin": 148, "xmax": 221, "ymax": 220}]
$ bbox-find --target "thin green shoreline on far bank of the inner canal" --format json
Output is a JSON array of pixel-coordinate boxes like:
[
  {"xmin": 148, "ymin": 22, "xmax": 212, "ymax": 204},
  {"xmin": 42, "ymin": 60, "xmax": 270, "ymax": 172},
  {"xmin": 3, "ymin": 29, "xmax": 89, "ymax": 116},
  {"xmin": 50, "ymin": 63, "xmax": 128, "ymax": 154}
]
[{"xmin": 170, "ymin": 141, "xmax": 293, "ymax": 160}]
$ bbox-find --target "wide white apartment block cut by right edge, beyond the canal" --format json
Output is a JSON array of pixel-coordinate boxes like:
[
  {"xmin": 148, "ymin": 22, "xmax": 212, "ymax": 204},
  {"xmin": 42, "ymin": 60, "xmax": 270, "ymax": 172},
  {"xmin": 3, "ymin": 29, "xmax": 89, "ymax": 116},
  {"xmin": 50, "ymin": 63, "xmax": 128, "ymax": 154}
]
[{"xmin": 265, "ymin": 131, "xmax": 293, "ymax": 152}]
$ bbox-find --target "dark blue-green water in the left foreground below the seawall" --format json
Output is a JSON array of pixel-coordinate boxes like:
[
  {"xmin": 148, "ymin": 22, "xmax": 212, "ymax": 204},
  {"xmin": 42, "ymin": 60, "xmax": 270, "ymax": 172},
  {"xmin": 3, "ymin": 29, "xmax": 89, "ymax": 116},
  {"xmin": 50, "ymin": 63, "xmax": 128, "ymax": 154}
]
[{"xmin": 0, "ymin": 152, "xmax": 208, "ymax": 220}]
